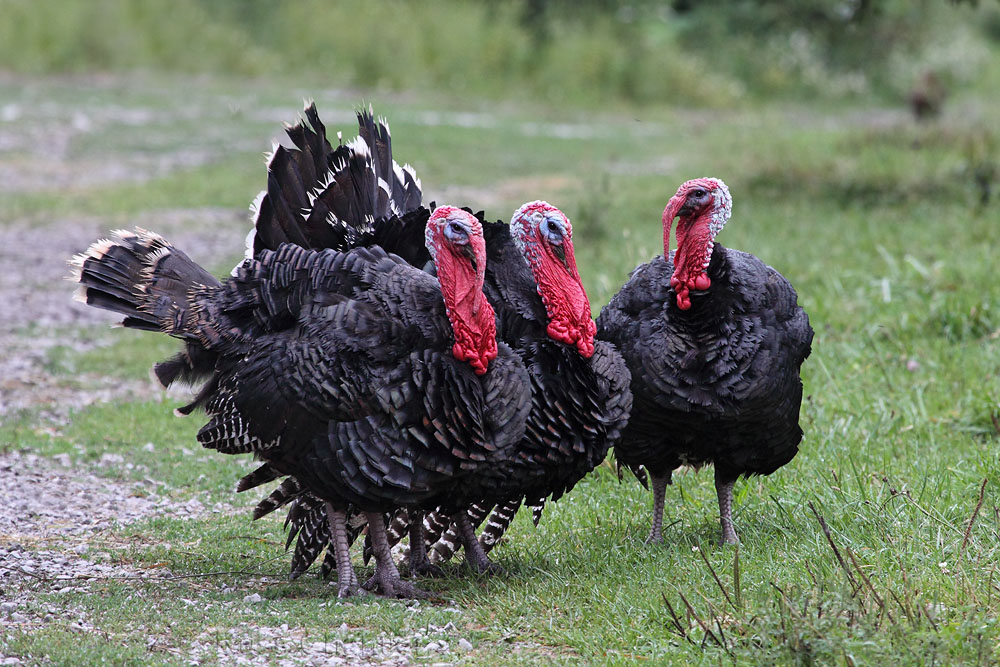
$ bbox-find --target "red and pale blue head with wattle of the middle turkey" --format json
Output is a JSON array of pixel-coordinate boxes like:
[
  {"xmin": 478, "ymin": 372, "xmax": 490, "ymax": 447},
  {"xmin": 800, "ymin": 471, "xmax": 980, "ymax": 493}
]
[{"xmin": 510, "ymin": 201, "xmax": 597, "ymax": 358}]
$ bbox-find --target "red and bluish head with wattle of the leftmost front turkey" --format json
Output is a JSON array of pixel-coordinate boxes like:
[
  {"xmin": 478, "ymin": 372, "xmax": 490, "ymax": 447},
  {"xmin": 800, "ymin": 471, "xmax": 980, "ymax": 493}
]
[{"xmin": 424, "ymin": 206, "xmax": 497, "ymax": 375}]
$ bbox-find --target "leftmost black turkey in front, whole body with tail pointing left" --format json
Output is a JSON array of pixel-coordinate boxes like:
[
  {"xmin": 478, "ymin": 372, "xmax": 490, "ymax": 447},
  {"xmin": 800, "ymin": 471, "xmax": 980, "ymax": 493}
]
[{"xmin": 74, "ymin": 206, "xmax": 530, "ymax": 596}]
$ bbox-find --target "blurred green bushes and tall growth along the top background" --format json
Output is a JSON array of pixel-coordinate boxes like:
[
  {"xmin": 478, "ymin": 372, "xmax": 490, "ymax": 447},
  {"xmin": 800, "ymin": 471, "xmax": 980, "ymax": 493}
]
[{"xmin": 0, "ymin": 0, "xmax": 1000, "ymax": 107}]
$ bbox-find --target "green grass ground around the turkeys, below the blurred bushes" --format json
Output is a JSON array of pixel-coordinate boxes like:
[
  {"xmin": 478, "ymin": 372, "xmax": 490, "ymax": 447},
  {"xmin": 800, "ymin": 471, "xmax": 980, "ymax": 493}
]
[{"xmin": 0, "ymin": 70, "xmax": 1000, "ymax": 664}]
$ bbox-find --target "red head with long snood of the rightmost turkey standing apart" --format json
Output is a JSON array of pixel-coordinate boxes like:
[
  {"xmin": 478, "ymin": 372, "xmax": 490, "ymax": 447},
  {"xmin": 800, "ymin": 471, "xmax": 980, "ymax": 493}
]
[{"xmin": 663, "ymin": 178, "xmax": 733, "ymax": 310}]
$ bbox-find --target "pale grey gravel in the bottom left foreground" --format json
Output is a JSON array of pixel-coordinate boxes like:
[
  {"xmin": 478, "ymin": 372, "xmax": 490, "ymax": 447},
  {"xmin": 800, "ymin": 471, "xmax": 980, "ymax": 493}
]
[{"xmin": 0, "ymin": 452, "xmax": 472, "ymax": 666}]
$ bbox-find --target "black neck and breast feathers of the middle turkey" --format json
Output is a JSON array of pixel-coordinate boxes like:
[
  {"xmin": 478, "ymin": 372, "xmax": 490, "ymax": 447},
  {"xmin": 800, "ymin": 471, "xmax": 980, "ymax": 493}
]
[{"xmin": 416, "ymin": 215, "xmax": 632, "ymax": 563}]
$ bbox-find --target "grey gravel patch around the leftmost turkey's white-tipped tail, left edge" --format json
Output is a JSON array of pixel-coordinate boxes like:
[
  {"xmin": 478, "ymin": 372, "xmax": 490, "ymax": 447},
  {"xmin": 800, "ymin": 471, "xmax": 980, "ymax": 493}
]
[{"xmin": 0, "ymin": 209, "xmax": 249, "ymax": 422}]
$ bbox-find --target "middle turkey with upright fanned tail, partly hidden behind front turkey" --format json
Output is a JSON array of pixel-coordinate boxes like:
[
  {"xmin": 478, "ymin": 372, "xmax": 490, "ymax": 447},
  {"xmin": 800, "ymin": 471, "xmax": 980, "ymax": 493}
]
[{"xmin": 247, "ymin": 104, "xmax": 631, "ymax": 575}]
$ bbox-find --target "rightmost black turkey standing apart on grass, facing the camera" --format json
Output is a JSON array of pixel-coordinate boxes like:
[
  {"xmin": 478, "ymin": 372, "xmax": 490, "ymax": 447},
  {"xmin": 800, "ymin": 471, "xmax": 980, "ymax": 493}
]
[{"xmin": 597, "ymin": 178, "xmax": 813, "ymax": 544}]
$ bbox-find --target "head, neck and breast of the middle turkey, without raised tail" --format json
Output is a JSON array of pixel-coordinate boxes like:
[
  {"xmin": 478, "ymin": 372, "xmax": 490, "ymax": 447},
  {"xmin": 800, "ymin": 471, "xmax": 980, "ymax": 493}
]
[{"xmin": 414, "ymin": 201, "xmax": 632, "ymax": 563}]
